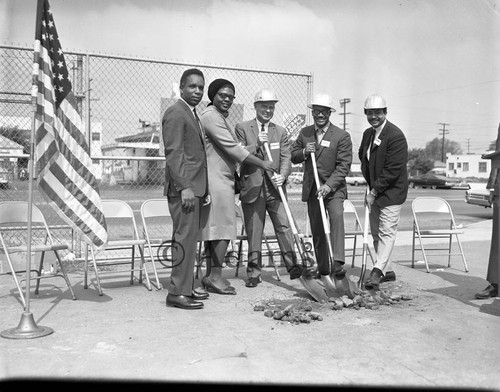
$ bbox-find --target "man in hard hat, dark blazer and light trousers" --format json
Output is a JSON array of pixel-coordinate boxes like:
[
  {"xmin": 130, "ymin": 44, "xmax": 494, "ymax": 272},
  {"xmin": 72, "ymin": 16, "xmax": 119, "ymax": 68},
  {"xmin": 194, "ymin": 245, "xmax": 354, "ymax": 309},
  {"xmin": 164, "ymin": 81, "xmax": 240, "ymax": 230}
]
[{"xmin": 358, "ymin": 94, "xmax": 408, "ymax": 290}]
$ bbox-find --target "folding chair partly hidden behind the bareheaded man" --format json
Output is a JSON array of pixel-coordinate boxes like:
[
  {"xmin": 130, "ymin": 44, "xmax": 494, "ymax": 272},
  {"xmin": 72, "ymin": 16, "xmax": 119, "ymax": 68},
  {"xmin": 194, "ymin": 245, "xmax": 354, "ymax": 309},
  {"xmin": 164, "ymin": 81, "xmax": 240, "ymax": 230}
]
[{"xmin": 141, "ymin": 198, "xmax": 179, "ymax": 289}]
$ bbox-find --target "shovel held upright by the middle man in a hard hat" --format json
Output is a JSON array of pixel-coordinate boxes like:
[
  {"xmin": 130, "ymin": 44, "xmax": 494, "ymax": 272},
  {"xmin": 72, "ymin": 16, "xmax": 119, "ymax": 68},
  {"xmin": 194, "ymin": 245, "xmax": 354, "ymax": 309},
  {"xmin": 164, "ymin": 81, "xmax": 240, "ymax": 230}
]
[{"xmin": 311, "ymin": 152, "xmax": 354, "ymax": 298}]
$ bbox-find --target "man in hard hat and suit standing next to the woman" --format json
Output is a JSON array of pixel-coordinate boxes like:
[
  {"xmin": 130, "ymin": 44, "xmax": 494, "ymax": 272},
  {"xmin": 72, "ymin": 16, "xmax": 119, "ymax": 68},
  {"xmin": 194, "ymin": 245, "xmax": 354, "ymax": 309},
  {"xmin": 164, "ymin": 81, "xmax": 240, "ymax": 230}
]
[{"xmin": 235, "ymin": 88, "xmax": 302, "ymax": 287}]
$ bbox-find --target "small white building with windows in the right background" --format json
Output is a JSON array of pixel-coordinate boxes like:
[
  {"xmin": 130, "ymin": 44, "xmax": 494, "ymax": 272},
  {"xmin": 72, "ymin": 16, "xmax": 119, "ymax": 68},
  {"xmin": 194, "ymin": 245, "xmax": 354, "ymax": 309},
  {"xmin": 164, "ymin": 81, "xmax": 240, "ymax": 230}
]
[{"xmin": 446, "ymin": 153, "xmax": 491, "ymax": 179}]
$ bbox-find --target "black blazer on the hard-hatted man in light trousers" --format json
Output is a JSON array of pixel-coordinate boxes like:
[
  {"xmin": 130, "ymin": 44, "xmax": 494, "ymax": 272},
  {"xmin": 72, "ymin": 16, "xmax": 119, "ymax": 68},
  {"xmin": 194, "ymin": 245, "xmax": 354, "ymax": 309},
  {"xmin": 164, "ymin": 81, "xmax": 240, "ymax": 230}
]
[{"xmin": 358, "ymin": 121, "xmax": 408, "ymax": 208}]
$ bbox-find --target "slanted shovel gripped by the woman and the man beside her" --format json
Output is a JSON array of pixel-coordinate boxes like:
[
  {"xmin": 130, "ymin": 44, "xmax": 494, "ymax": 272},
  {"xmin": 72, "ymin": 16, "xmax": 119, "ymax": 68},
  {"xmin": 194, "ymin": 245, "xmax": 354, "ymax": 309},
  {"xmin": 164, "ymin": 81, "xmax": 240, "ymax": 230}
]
[{"xmin": 264, "ymin": 142, "xmax": 329, "ymax": 302}]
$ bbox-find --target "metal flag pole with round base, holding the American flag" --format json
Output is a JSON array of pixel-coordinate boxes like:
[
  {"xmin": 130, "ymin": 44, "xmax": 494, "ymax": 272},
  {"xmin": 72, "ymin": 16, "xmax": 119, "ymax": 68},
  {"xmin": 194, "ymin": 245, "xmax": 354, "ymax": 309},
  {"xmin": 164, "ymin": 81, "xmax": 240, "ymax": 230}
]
[{"xmin": 0, "ymin": 0, "xmax": 54, "ymax": 339}]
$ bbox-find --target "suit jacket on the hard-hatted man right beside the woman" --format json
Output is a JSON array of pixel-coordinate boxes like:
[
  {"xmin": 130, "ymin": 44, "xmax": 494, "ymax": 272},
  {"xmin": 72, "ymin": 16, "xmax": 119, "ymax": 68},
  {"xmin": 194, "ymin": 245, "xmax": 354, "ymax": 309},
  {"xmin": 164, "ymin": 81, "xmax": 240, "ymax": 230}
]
[{"xmin": 235, "ymin": 119, "xmax": 292, "ymax": 203}]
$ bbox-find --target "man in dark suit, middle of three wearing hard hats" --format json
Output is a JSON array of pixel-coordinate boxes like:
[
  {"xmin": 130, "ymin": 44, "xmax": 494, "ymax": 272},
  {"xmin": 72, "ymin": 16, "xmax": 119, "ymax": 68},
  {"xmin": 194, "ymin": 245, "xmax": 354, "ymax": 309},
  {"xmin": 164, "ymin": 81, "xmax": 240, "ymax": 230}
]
[{"xmin": 292, "ymin": 94, "xmax": 352, "ymax": 279}]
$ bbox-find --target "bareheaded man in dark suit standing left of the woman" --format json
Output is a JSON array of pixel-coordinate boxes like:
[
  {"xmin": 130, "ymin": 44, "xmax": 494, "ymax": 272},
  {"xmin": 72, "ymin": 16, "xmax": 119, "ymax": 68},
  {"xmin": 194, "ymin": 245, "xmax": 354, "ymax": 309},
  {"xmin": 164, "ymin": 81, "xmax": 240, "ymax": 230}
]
[{"xmin": 162, "ymin": 68, "xmax": 208, "ymax": 309}]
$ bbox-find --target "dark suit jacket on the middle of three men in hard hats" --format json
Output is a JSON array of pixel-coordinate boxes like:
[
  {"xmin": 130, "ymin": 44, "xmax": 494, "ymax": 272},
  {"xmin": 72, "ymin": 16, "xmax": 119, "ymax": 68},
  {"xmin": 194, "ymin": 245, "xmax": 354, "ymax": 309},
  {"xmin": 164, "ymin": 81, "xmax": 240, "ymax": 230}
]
[{"xmin": 292, "ymin": 123, "xmax": 352, "ymax": 201}]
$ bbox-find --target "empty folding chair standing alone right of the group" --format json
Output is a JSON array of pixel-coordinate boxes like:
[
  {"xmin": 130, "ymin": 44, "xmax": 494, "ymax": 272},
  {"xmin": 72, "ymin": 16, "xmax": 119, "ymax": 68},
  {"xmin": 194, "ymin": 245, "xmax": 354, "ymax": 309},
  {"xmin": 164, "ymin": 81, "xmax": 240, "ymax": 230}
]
[{"xmin": 411, "ymin": 197, "xmax": 469, "ymax": 272}]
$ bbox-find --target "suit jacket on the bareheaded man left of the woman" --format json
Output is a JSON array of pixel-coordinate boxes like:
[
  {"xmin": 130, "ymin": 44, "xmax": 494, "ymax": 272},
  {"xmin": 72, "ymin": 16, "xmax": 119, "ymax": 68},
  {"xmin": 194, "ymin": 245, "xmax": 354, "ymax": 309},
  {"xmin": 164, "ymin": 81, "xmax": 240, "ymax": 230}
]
[{"xmin": 162, "ymin": 99, "xmax": 207, "ymax": 197}]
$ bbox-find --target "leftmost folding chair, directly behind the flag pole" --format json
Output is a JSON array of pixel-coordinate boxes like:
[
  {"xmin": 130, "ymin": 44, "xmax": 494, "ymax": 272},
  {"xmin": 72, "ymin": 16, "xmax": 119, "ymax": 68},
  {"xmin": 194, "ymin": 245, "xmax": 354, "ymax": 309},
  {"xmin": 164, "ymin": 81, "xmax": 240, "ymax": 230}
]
[{"xmin": 0, "ymin": 201, "xmax": 76, "ymax": 307}]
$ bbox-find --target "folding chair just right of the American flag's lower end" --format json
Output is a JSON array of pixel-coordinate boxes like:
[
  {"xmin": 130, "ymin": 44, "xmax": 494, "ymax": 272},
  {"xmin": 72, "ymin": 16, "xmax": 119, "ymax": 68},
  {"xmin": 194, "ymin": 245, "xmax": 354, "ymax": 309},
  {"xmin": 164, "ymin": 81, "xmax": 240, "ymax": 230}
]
[{"xmin": 83, "ymin": 199, "xmax": 152, "ymax": 295}]
